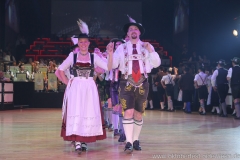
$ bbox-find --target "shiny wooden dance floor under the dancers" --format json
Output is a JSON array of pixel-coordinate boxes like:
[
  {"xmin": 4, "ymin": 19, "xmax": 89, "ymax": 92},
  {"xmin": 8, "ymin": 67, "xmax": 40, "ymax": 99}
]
[{"xmin": 0, "ymin": 109, "xmax": 240, "ymax": 160}]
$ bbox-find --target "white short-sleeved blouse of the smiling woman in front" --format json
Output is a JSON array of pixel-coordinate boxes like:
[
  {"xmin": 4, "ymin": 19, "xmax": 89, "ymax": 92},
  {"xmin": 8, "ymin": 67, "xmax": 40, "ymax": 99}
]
[{"xmin": 58, "ymin": 52, "xmax": 108, "ymax": 71}]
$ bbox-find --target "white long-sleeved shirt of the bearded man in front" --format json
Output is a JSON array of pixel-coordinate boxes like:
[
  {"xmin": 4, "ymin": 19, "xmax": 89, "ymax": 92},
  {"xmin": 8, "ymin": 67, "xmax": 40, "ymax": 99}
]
[{"xmin": 113, "ymin": 40, "xmax": 161, "ymax": 75}]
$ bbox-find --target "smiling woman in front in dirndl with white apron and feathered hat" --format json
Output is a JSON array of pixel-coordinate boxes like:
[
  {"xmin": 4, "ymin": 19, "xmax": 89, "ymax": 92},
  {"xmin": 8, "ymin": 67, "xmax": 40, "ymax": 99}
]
[{"xmin": 56, "ymin": 20, "xmax": 112, "ymax": 154}]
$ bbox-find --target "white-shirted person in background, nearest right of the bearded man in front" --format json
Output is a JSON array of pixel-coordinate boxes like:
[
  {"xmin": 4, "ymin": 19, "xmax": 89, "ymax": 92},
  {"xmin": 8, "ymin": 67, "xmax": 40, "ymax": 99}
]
[{"xmin": 161, "ymin": 67, "xmax": 176, "ymax": 112}]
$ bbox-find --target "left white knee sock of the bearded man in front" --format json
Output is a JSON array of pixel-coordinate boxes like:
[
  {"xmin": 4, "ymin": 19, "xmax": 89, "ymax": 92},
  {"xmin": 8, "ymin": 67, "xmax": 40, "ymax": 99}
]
[{"xmin": 123, "ymin": 118, "xmax": 134, "ymax": 144}]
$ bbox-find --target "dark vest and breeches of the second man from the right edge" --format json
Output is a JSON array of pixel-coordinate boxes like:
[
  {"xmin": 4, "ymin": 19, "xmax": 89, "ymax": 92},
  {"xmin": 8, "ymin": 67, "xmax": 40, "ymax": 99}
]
[{"xmin": 216, "ymin": 68, "xmax": 229, "ymax": 103}]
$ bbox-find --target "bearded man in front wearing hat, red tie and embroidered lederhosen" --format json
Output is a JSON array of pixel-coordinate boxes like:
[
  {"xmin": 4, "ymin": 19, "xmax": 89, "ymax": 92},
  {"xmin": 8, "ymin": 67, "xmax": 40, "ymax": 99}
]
[{"xmin": 111, "ymin": 22, "xmax": 161, "ymax": 153}]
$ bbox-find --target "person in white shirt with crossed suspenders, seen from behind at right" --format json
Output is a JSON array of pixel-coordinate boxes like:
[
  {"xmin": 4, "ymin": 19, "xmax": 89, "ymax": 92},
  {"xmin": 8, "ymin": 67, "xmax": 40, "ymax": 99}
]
[{"xmin": 194, "ymin": 68, "xmax": 208, "ymax": 115}]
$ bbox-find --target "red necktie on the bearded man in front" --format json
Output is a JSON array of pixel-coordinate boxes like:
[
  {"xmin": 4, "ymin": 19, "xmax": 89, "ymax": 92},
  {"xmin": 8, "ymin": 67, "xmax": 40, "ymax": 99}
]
[{"xmin": 132, "ymin": 44, "xmax": 141, "ymax": 83}]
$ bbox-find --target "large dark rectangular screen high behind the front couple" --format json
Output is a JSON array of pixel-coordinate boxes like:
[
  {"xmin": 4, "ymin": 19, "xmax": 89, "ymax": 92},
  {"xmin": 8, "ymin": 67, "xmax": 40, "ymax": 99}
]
[{"xmin": 51, "ymin": 0, "xmax": 142, "ymax": 37}]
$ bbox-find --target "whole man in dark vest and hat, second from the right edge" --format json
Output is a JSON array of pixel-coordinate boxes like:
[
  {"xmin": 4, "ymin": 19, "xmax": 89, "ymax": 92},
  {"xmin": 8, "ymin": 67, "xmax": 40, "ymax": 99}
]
[{"xmin": 211, "ymin": 59, "xmax": 229, "ymax": 117}]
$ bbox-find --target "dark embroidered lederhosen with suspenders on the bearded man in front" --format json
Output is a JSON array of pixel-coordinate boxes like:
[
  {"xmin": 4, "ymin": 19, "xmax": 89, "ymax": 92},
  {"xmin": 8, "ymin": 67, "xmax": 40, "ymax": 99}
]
[{"xmin": 119, "ymin": 44, "xmax": 149, "ymax": 113}]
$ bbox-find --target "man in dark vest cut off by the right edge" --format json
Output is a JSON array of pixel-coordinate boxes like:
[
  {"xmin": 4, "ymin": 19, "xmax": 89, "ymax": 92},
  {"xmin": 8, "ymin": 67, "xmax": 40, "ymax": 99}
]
[{"xmin": 227, "ymin": 57, "xmax": 240, "ymax": 120}]
